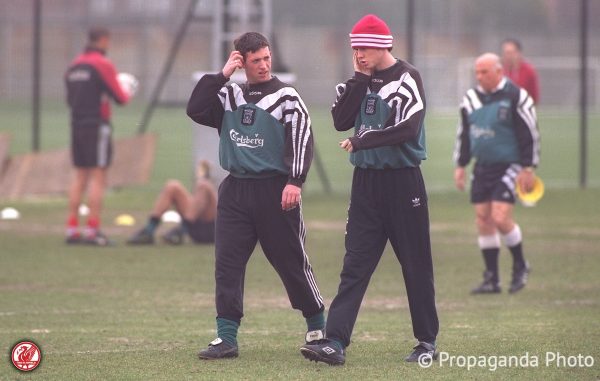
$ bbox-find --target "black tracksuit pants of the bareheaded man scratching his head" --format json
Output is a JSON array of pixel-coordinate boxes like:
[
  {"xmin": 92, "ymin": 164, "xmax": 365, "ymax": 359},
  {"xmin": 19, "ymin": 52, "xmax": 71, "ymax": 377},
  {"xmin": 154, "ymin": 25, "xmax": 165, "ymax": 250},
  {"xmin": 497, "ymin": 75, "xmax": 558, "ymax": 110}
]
[{"xmin": 215, "ymin": 175, "xmax": 323, "ymax": 323}]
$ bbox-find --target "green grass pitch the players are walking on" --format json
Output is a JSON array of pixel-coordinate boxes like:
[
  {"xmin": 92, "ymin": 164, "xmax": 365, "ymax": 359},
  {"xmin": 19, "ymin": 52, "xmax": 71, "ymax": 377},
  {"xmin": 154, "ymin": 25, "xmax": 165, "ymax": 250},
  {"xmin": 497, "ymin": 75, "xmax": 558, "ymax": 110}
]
[{"xmin": 0, "ymin": 104, "xmax": 600, "ymax": 380}]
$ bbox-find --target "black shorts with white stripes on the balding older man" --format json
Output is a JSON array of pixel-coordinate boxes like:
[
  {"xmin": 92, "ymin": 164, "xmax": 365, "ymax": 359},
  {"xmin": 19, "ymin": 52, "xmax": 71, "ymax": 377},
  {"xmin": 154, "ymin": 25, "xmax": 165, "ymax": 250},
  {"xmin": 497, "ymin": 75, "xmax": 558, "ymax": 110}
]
[{"xmin": 471, "ymin": 164, "xmax": 521, "ymax": 204}]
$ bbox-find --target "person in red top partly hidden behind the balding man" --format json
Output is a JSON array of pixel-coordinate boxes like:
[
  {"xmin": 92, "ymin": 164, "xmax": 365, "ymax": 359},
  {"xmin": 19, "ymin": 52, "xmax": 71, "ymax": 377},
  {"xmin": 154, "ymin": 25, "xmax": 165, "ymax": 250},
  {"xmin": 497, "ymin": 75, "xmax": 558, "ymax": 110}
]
[{"xmin": 502, "ymin": 38, "xmax": 540, "ymax": 104}]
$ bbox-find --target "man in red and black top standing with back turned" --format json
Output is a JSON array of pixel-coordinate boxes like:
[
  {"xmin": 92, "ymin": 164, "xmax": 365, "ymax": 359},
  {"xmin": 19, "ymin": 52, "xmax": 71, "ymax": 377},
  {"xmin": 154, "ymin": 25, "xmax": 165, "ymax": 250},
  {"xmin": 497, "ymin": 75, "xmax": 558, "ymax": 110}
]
[{"xmin": 65, "ymin": 28, "xmax": 130, "ymax": 246}]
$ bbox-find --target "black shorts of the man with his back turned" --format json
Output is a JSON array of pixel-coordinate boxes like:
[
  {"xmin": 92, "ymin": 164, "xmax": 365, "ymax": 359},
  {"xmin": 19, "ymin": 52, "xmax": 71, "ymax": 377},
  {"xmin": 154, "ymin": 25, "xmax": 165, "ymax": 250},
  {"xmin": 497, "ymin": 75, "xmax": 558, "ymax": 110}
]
[{"xmin": 71, "ymin": 120, "xmax": 112, "ymax": 168}]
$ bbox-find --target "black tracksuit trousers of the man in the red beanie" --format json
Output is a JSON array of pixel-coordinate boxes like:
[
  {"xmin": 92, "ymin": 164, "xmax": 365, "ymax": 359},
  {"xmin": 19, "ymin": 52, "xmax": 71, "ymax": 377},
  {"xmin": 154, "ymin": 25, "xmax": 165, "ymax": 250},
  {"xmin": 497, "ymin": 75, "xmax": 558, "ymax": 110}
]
[{"xmin": 326, "ymin": 167, "xmax": 439, "ymax": 347}]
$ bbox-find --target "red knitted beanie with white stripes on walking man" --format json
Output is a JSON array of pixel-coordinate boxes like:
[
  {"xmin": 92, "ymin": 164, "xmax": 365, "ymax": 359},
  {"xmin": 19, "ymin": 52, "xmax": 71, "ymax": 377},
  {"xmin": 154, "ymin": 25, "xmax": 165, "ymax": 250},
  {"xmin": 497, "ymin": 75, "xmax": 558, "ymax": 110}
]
[{"xmin": 350, "ymin": 15, "xmax": 394, "ymax": 49}]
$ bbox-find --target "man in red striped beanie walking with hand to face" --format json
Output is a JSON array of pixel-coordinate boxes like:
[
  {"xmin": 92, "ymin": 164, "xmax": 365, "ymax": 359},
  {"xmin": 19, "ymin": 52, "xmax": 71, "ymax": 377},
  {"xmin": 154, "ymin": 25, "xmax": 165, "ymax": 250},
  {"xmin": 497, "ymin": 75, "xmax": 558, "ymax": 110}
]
[{"xmin": 300, "ymin": 15, "xmax": 439, "ymax": 365}]
